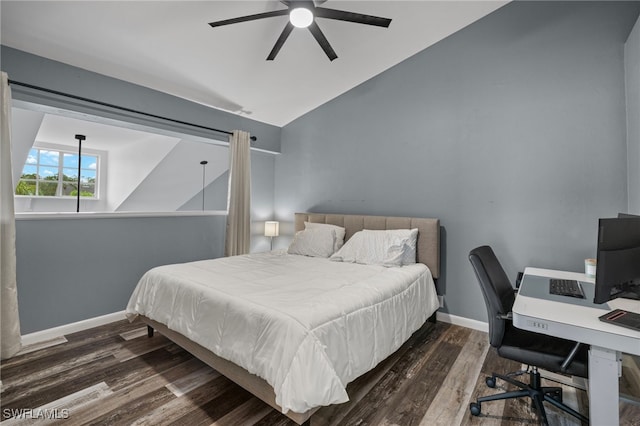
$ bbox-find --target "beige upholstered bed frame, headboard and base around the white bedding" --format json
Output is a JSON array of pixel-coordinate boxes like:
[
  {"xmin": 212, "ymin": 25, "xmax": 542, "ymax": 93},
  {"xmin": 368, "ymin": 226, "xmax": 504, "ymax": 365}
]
[{"xmin": 138, "ymin": 213, "xmax": 440, "ymax": 425}]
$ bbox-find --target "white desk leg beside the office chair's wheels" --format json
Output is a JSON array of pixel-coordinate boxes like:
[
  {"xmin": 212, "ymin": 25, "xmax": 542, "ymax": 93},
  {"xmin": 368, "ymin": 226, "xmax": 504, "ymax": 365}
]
[{"xmin": 589, "ymin": 346, "xmax": 622, "ymax": 426}]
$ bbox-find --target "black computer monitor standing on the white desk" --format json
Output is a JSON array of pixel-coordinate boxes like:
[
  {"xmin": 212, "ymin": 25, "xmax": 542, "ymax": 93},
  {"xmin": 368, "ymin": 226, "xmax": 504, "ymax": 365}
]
[{"xmin": 593, "ymin": 215, "xmax": 640, "ymax": 303}]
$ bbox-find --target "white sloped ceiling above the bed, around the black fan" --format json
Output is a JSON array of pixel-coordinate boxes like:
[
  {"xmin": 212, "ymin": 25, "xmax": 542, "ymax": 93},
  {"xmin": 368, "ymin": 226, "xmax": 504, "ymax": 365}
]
[{"xmin": 0, "ymin": 0, "xmax": 507, "ymax": 126}]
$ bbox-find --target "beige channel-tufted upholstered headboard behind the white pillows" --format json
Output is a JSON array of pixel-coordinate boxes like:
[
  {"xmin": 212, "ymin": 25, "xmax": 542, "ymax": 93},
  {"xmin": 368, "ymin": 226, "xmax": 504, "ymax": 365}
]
[{"xmin": 295, "ymin": 213, "xmax": 440, "ymax": 278}]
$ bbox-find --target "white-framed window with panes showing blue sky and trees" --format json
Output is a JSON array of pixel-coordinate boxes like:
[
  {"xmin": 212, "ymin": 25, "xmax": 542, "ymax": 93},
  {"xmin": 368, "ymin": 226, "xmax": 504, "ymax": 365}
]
[{"xmin": 15, "ymin": 147, "xmax": 100, "ymax": 198}]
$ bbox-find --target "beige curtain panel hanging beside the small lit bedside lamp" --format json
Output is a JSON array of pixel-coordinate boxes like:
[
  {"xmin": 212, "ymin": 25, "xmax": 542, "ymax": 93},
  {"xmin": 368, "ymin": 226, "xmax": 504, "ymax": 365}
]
[{"xmin": 224, "ymin": 130, "xmax": 251, "ymax": 256}]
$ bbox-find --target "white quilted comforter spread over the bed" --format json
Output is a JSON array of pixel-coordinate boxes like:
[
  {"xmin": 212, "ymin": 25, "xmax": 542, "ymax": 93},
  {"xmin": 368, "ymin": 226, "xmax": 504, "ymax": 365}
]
[{"xmin": 126, "ymin": 252, "xmax": 438, "ymax": 413}]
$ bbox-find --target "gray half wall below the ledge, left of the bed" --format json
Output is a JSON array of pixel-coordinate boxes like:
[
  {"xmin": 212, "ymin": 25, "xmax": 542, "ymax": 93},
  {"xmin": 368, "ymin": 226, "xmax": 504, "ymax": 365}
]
[{"xmin": 16, "ymin": 216, "xmax": 226, "ymax": 334}]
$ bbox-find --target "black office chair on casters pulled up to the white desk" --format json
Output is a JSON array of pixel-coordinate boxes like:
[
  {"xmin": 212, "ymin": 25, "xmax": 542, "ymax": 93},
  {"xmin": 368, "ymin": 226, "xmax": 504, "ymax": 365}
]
[{"xmin": 469, "ymin": 246, "xmax": 589, "ymax": 425}]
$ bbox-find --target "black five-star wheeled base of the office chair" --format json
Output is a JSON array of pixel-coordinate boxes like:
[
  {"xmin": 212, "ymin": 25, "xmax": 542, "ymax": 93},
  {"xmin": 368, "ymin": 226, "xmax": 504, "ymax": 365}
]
[{"xmin": 469, "ymin": 367, "xmax": 589, "ymax": 425}]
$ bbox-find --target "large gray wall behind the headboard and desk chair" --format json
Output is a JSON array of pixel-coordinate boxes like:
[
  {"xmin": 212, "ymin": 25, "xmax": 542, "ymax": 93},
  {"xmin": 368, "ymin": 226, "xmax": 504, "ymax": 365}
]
[{"xmin": 275, "ymin": 2, "xmax": 640, "ymax": 321}]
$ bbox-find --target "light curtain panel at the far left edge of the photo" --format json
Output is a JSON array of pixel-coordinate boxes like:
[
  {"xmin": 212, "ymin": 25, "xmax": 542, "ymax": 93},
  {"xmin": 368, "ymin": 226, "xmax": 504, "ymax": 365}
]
[{"xmin": 0, "ymin": 72, "xmax": 22, "ymax": 359}]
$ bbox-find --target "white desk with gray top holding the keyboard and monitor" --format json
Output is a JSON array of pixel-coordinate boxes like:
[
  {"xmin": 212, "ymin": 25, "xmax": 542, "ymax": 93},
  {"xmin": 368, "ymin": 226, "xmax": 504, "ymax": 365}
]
[{"xmin": 513, "ymin": 268, "xmax": 640, "ymax": 426}]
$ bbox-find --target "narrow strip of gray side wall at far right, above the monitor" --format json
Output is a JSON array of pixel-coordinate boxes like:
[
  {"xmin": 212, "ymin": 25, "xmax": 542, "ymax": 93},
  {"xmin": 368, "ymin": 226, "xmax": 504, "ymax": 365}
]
[{"xmin": 624, "ymin": 19, "xmax": 640, "ymax": 214}]
